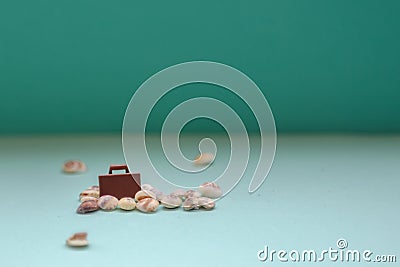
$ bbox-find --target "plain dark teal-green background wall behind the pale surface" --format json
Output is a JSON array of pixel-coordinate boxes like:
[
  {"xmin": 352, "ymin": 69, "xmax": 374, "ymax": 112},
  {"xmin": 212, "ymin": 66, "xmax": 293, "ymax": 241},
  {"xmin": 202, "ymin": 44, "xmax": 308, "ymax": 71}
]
[{"xmin": 0, "ymin": 0, "xmax": 400, "ymax": 134}]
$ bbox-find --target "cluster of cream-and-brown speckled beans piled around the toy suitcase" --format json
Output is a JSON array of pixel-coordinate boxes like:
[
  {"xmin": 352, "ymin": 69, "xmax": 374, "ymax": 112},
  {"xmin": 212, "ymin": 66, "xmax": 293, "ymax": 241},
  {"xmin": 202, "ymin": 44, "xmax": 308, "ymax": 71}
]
[{"xmin": 76, "ymin": 182, "xmax": 222, "ymax": 214}]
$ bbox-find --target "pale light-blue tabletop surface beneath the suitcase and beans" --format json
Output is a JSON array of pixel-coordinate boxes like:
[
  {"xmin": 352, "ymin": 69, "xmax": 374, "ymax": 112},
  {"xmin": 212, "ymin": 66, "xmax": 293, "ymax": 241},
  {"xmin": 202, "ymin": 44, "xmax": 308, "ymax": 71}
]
[{"xmin": 0, "ymin": 135, "xmax": 400, "ymax": 267}]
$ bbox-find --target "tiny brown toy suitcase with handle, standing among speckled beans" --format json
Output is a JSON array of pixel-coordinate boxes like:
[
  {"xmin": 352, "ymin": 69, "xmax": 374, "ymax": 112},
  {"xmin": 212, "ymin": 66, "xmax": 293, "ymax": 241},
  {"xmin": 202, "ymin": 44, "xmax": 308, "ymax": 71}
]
[{"xmin": 99, "ymin": 164, "xmax": 140, "ymax": 199}]
